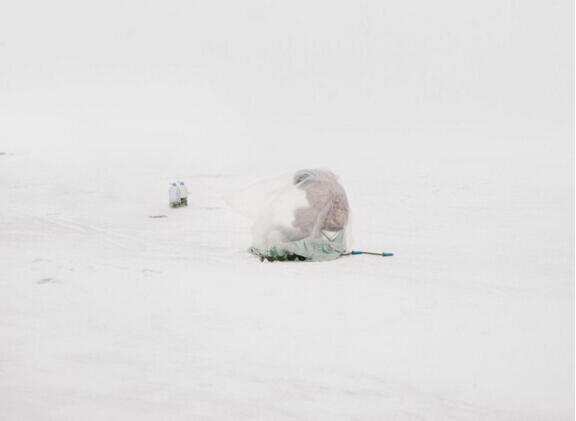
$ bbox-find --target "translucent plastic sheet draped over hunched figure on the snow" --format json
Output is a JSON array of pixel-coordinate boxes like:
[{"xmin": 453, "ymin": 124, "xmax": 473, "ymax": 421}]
[{"xmin": 231, "ymin": 169, "xmax": 350, "ymax": 261}]
